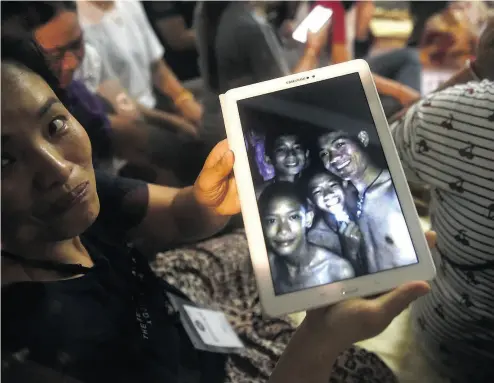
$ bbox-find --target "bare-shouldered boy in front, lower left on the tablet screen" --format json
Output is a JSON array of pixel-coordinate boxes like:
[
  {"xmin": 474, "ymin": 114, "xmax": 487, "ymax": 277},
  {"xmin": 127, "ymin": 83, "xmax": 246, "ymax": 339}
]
[{"xmin": 258, "ymin": 181, "xmax": 354, "ymax": 294}]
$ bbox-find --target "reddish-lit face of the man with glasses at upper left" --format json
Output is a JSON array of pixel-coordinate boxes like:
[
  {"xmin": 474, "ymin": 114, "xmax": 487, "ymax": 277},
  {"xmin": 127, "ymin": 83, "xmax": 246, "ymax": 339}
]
[{"xmin": 34, "ymin": 11, "xmax": 84, "ymax": 88}]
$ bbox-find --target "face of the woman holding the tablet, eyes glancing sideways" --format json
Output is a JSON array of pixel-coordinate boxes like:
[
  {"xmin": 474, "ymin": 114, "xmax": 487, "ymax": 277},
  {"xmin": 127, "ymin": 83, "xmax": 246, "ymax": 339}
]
[{"xmin": 1, "ymin": 63, "xmax": 99, "ymax": 245}]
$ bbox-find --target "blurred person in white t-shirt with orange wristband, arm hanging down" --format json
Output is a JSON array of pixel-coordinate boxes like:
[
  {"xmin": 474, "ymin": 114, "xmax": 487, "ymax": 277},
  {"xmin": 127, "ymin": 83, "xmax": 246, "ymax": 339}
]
[{"xmin": 78, "ymin": 0, "xmax": 202, "ymax": 125}]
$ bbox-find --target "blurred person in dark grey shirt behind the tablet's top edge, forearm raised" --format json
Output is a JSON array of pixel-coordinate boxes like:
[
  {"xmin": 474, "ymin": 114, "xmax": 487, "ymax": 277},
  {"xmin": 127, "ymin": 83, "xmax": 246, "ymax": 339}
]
[{"xmin": 195, "ymin": 1, "xmax": 327, "ymax": 152}]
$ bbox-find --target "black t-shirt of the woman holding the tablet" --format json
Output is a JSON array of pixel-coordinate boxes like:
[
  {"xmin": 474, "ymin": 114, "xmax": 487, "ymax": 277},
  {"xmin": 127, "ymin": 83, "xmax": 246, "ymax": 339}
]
[{"xmin": 2, "ymin": 173, "xmax": 224, "ymax": 383}]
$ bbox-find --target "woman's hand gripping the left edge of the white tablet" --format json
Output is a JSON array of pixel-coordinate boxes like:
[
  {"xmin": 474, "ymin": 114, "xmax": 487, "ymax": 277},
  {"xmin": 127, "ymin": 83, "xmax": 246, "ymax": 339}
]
[{"xmin": 194, "ymin": 140, "xmax": 240, "ymax": 215}]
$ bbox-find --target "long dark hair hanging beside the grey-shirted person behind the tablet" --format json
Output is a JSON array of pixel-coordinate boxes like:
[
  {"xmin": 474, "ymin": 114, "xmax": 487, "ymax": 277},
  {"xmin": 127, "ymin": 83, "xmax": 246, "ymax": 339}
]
[{"xmin": 202, "ymin": 1, "xmax": 231, "ymax": 92}]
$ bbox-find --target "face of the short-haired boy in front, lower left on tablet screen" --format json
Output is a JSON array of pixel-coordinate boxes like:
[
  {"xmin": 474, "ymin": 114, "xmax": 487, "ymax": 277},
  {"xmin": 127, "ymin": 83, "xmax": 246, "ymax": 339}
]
[{"xmin": 262, "ymin": 196, "xmax": 312, "ymax": 257}]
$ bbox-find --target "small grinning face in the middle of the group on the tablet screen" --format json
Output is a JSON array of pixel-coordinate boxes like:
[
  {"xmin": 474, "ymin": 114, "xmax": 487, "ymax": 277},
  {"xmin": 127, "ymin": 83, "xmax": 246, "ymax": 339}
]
[{"xmin": 309, "ymin": 173, "xmax": 345, "ymax": 213}]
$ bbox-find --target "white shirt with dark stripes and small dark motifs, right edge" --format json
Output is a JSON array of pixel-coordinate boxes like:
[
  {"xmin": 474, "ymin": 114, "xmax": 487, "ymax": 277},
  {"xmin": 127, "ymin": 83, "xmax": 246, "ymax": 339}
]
[{"xmin": 391, "ymin": 80, "xmax": 494, "ymax": 383}]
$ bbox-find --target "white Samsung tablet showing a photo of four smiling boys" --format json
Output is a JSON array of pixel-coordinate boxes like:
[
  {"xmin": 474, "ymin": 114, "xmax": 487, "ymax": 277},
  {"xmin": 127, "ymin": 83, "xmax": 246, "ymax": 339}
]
[{"xmin": 220, "ymin": 60, "xmax": 435, "ymax": 316}]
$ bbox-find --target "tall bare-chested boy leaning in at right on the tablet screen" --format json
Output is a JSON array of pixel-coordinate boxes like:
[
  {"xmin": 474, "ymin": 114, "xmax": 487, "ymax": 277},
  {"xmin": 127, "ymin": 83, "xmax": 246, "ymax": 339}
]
[{"xmin": 318, "ymin": 131, "xmax": 417, "ymax": 273}]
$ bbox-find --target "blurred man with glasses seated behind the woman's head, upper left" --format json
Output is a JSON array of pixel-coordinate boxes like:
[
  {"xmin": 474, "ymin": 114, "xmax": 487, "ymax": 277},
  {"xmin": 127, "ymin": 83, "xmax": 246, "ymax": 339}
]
[{"xmin": 2, "ymin": 1, "xmax": 205, "ymax": 185}]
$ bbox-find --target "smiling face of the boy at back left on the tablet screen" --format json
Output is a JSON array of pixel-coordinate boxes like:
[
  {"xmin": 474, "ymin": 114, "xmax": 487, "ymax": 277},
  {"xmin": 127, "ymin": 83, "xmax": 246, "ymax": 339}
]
[{"xmin": 269, "ymin": 135, "xmax": 308, "ymax": 176}]
